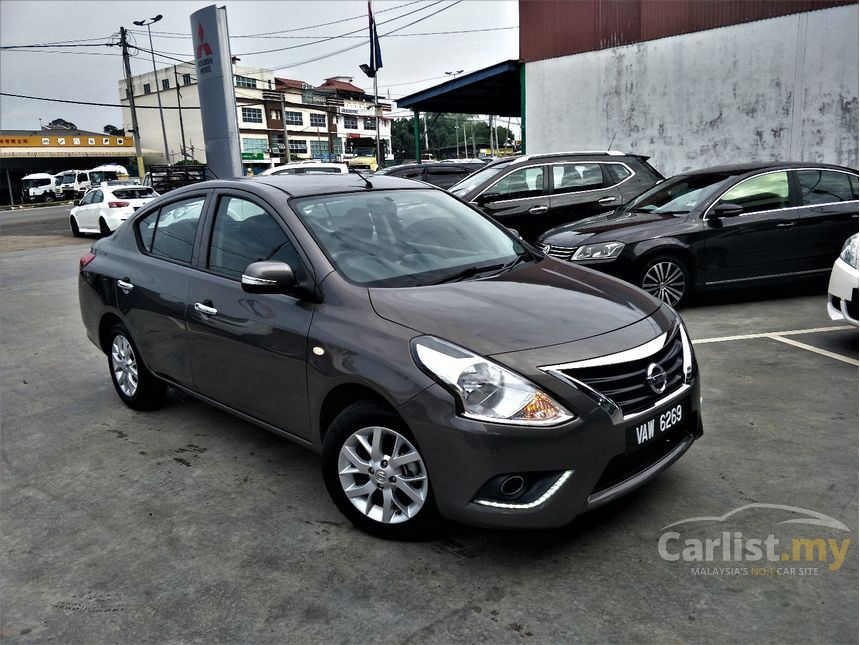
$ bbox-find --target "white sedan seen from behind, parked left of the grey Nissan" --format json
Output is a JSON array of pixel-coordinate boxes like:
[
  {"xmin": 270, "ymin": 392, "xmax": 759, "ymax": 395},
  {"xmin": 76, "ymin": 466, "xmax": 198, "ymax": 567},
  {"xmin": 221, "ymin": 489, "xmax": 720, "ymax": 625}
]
[{"xmin": 69, "ymin": 183, "xmax": 158, "ymax": 237}]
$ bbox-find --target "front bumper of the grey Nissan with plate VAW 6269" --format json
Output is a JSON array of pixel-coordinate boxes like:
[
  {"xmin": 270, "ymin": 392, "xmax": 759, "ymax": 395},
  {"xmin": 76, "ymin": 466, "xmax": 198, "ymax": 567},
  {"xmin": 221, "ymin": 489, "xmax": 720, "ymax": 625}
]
[{"xmin": 399, "ymin": 375, "xmax": 702, "ymax": 528}]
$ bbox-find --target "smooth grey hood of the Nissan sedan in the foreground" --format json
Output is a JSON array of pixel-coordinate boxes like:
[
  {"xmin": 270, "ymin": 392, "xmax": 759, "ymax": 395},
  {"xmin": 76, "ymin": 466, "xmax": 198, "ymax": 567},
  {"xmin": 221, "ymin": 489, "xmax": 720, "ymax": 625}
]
[{"xmin": 369, "ymin": 258, "xmax": 660, "ymax": 356}]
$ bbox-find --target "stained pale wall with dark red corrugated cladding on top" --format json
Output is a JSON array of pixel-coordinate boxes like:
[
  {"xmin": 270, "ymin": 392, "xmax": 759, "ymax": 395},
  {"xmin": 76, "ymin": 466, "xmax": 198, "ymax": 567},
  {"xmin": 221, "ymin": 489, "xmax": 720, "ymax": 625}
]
[{"xmin": 519, "ymin": 0, "xmax": 858, "ymax": 176}]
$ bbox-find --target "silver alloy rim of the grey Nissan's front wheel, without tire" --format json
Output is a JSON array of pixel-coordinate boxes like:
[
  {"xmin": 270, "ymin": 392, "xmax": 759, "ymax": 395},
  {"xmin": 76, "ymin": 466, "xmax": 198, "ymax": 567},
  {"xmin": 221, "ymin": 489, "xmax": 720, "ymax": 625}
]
[{"xmin": 337, "ymin": 426, "xmax": 429, "ymax": 524}]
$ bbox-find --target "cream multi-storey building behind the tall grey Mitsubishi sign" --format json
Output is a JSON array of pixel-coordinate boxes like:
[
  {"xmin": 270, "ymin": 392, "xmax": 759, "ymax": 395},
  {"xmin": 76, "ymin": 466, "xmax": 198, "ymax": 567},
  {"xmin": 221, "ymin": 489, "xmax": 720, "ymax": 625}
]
[{"xmin": 119, "ymin": 63, "xmax": 391, "ymax": 173}]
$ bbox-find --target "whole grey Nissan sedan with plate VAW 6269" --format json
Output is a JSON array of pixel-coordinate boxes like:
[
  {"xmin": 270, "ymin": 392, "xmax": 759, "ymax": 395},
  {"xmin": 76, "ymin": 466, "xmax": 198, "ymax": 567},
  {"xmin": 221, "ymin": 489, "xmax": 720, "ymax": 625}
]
[{"xmin": 79, "ymin": 174, "xmax": 702, "ymax": 538}]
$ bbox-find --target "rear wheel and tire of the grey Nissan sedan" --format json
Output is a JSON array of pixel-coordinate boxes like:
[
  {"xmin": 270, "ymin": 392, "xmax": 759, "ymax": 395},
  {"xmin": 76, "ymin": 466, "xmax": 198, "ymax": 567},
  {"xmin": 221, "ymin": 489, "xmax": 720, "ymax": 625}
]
[{"xmin": 108, "ymin": 324, "xmax": 167, "ymax": 410}]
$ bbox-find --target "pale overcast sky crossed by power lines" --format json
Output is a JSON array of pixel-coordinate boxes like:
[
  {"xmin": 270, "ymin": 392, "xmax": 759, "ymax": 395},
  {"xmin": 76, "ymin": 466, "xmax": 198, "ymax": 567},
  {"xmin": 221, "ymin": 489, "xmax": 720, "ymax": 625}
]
[{"xmin": 0, "ymin": 0, "xmax": 519, "ymax": 132}]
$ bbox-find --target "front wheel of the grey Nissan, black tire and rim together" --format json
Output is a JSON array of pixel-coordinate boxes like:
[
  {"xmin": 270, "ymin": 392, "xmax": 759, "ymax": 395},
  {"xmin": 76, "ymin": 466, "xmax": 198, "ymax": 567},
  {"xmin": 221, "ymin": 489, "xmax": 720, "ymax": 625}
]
[{"xmin": 322, "ymin": 401, "xmax": 442, "ymax": 540}]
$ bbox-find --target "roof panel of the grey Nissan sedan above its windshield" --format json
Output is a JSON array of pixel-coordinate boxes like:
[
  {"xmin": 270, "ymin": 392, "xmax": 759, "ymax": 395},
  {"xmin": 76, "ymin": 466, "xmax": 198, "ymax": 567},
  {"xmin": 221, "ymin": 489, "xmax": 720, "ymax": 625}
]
[{"xmin": 163, "ymin": 172, "xmax": 430, "ymax": 197}]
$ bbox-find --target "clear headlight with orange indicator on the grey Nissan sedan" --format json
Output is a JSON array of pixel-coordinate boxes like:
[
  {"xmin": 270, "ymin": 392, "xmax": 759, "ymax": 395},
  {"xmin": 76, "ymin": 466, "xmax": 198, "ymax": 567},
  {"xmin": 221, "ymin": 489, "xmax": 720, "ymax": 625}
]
[{"xmin": 412, "ymin": 336, "xmax": 574, "ymax": 426}]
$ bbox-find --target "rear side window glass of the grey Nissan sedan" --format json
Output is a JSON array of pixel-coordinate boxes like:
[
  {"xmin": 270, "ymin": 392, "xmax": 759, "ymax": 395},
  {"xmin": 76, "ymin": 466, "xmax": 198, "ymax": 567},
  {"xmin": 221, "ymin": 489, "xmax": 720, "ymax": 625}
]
[{"xmin": 137, "ymin": 197, "xmax": 206, "ymax": 264}]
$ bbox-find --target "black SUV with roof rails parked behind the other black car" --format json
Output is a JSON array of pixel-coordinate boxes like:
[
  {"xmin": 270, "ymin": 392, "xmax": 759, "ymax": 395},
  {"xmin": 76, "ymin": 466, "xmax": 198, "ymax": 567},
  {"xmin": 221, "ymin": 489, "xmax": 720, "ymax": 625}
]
[{"xmin": 450, "ymin": 151, "xmax": 663, "ymax": 242}]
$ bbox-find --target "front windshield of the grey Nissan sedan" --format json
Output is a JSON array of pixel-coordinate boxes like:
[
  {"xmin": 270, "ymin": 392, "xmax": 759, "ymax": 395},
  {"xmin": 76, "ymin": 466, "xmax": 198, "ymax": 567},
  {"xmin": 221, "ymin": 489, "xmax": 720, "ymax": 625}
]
[{"xmin": 291, "ymin": 190, "xmax": 526, "ymax": 287}]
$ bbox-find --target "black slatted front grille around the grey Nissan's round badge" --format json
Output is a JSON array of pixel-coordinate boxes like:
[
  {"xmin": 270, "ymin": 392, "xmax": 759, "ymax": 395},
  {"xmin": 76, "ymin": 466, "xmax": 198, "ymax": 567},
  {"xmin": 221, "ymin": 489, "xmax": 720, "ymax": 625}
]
[{"xmin": 561, "ymin": 330, "xmax": 684, "ymax": 415}]
